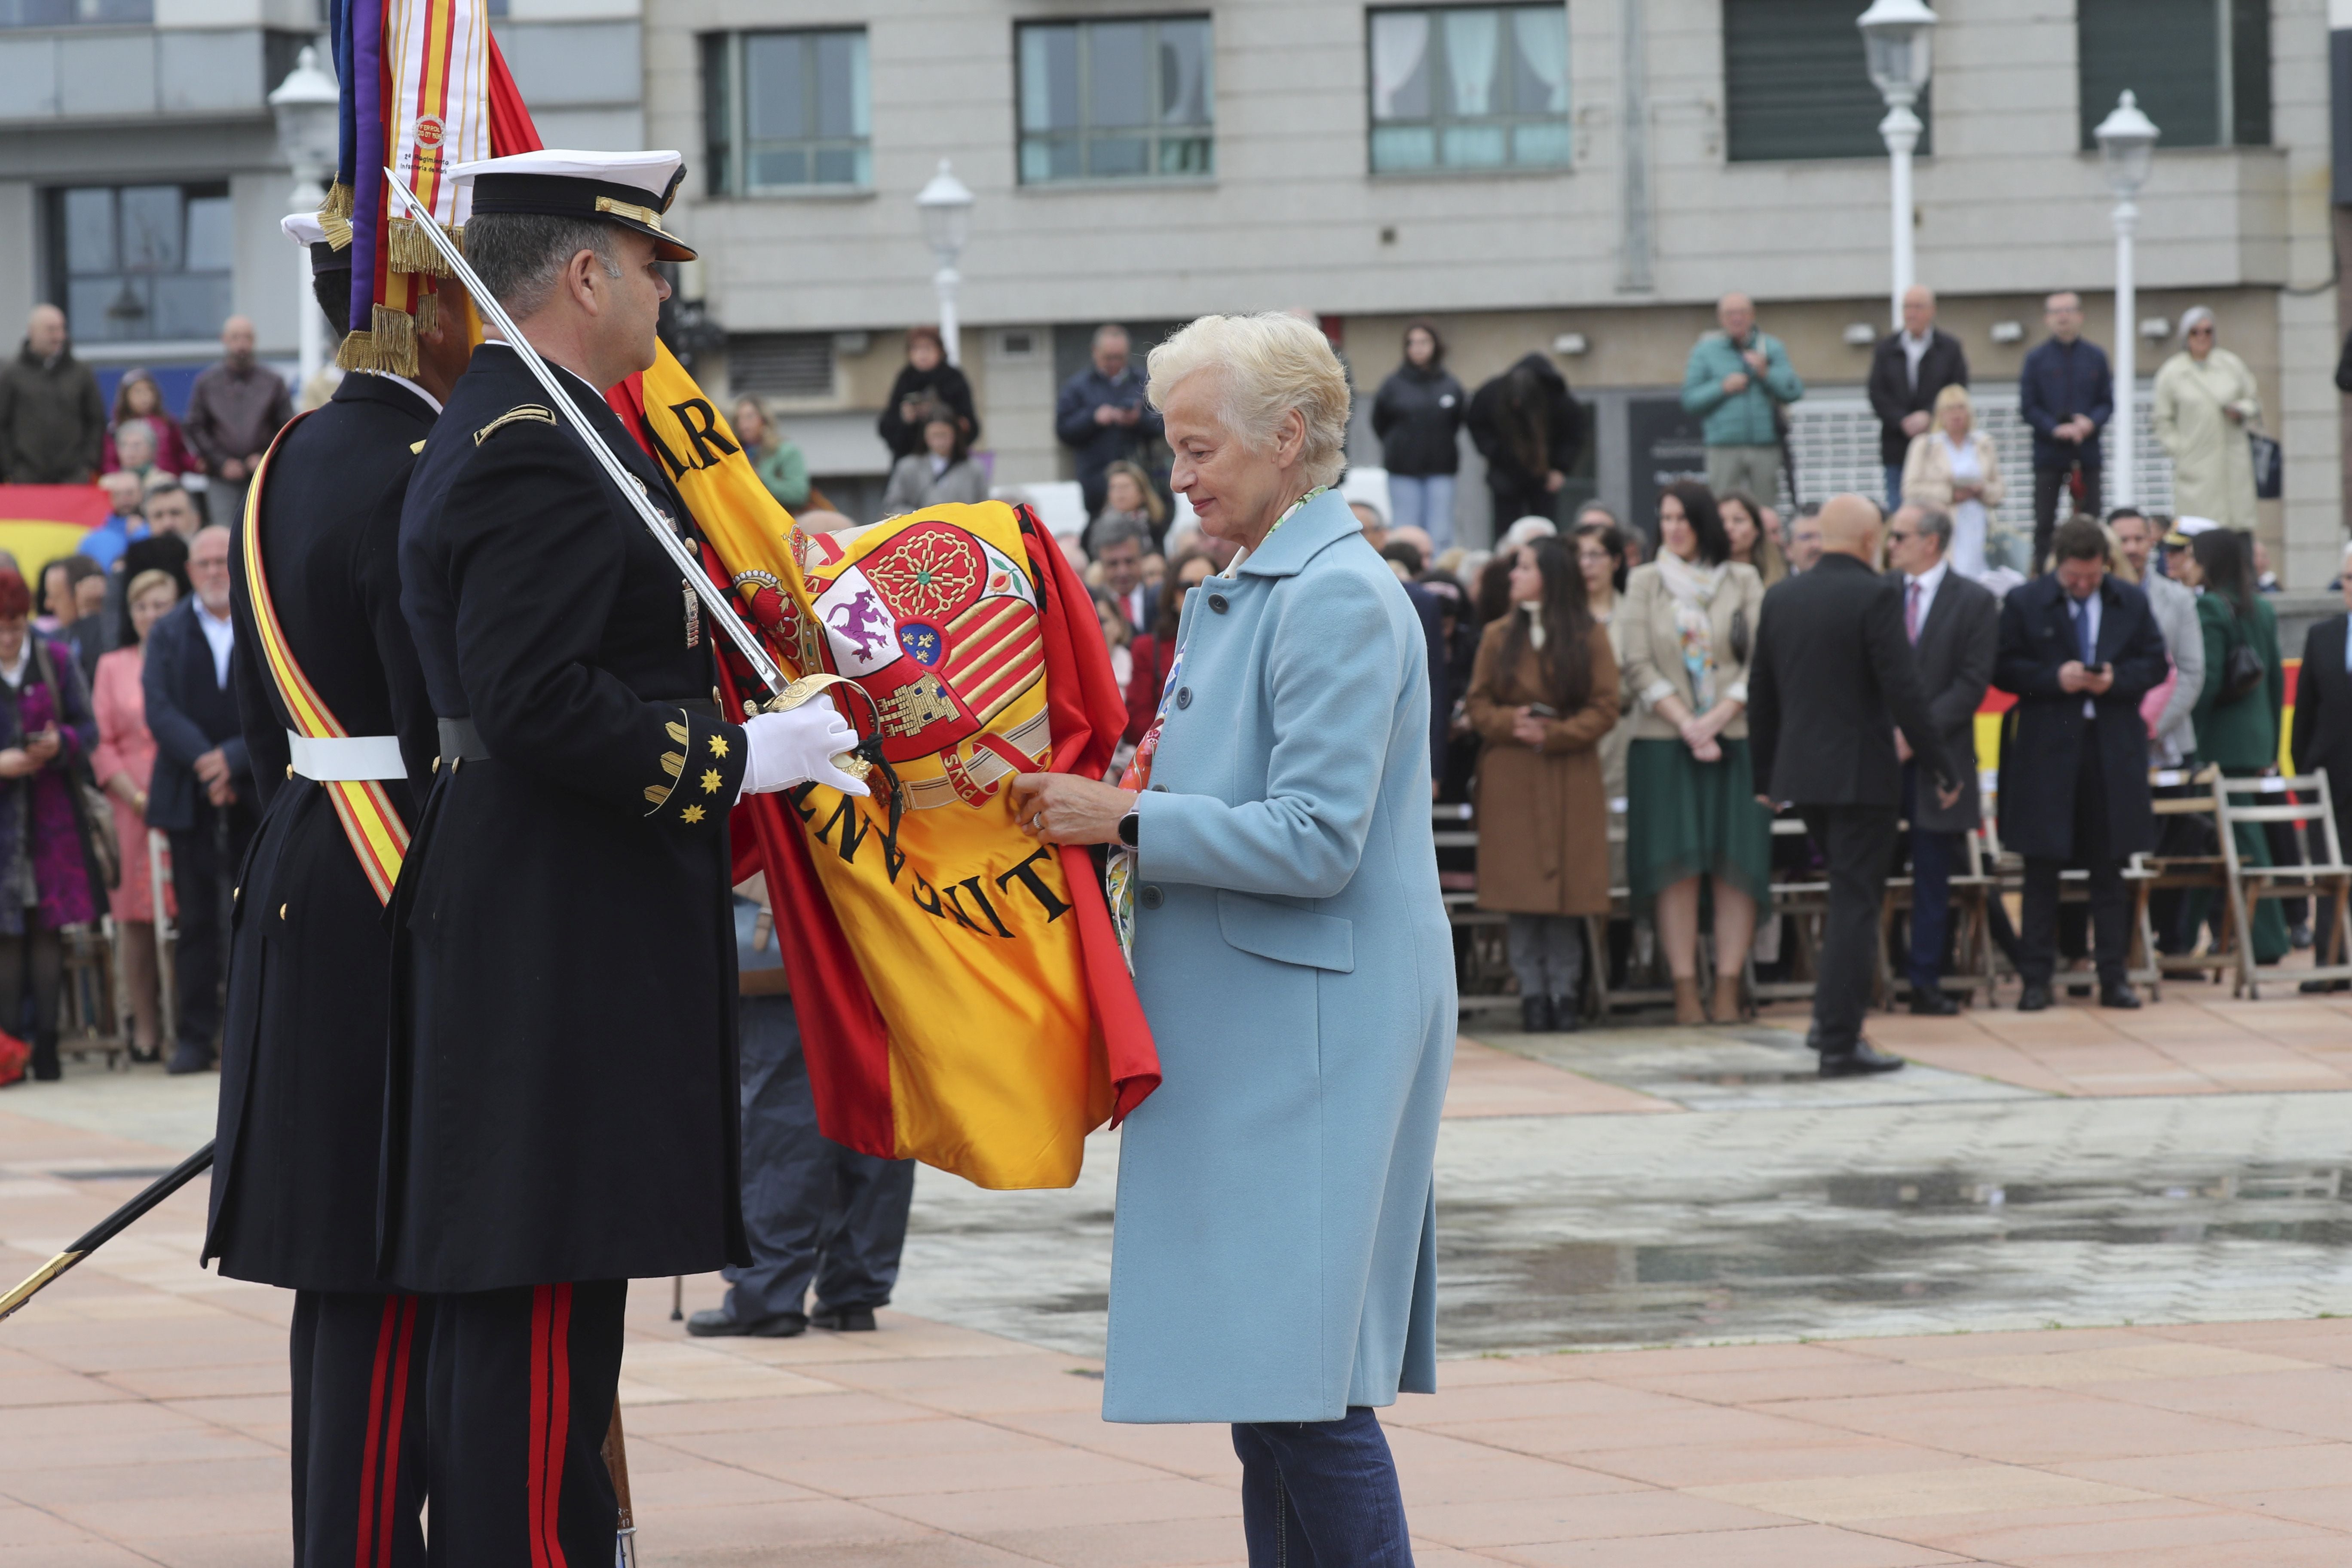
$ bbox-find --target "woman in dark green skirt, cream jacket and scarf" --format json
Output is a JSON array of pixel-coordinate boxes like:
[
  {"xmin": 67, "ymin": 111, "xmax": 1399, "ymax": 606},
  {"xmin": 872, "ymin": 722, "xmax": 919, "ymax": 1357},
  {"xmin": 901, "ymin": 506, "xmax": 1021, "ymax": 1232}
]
[{"xmin": 1611, "ymin": 482, "xmax": 1771, "ymax": 1023}]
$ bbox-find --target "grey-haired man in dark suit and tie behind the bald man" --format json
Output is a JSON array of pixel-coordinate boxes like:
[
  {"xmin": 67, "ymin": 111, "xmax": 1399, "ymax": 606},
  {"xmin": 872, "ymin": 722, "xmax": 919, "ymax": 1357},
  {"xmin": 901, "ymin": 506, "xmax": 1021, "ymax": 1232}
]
[{"xmin": 1886, "ymin": 505, "xmax": 2002, "ymax": 1018}]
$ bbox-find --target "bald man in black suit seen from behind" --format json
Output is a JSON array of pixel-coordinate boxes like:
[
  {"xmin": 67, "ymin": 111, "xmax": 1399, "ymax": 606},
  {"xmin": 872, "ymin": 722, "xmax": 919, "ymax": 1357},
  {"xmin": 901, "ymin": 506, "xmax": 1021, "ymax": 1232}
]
[{"xmin": 1748, "ymin": 496, "xmax": 1959, "ymax": 1079}]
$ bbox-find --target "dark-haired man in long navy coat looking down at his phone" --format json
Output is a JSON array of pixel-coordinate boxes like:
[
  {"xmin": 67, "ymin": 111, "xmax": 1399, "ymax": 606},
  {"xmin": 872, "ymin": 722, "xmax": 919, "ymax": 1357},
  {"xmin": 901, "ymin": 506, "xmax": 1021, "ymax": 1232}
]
[{"xmin": 1992, "ymin": 517, "xmax": 2166, "ymax": 1013}]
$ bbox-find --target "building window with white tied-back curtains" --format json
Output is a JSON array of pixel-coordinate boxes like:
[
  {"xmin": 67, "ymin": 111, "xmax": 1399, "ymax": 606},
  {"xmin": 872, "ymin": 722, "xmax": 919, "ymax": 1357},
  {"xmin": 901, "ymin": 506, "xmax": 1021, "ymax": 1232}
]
[{"xmin": 1364, "ymin": 5, "xmax": 1574, "ymax": 174}]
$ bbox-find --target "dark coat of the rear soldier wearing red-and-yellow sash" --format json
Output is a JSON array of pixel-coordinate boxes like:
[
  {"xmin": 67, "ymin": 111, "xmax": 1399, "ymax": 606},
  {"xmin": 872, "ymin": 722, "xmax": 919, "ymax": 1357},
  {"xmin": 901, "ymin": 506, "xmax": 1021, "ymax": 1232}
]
[{"xmin": 205, "ymin": 374, "xmax": 433, "ymax": 1291}]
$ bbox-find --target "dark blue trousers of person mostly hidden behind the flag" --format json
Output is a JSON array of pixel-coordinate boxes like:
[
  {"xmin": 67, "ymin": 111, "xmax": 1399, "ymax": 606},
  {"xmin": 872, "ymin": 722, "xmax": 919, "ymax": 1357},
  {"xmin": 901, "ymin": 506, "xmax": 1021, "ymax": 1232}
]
[{"xmin": 724, "ymin": 997, "xmax": 915, "ymax": 1323}]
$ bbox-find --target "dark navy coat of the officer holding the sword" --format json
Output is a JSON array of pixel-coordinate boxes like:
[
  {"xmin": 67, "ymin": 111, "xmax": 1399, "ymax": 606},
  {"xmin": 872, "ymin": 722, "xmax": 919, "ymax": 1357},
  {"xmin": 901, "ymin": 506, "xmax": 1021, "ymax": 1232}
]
[{"xmin": 379, "ymin": 343, "xmax": 748, "ymax": 1291}]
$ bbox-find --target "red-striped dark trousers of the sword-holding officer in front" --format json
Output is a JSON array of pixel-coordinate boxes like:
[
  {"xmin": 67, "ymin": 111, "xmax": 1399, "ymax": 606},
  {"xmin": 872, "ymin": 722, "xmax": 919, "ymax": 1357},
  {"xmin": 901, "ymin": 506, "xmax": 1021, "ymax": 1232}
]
[{"xmin": 426, "ymin": 1279, "xmax": 628, "ymax": 1568}]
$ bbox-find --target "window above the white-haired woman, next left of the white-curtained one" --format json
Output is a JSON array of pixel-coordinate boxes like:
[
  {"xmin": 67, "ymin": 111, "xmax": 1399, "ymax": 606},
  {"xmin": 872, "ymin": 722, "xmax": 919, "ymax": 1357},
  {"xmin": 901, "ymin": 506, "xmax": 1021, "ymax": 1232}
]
[{"xmin": 1018, "ymin": 16, "xmax": 1216, "ymax": 186}]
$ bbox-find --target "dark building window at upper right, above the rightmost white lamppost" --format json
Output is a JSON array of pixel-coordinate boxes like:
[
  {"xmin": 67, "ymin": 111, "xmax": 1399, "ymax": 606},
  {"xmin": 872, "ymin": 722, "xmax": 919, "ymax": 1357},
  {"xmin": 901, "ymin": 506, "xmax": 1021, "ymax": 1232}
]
[{"xmin": 2074, "ymin": 0, "xmax": 2269, "ymax": 153}]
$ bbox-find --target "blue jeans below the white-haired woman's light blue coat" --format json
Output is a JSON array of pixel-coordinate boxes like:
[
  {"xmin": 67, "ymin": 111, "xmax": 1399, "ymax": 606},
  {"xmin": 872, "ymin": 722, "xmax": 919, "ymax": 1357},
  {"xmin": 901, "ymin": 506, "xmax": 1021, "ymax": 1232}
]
[{"xmin": 1232, "ymin": 1406, "xmax": 1414, "ymax": 1568}]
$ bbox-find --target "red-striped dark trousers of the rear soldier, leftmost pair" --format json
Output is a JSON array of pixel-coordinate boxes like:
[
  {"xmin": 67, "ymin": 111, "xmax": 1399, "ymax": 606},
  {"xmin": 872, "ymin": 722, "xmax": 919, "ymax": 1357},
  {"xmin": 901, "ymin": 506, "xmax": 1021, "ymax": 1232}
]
[{"xmin": 289, "ymin": 1291, "xmax": 433, "ymax": 1568}]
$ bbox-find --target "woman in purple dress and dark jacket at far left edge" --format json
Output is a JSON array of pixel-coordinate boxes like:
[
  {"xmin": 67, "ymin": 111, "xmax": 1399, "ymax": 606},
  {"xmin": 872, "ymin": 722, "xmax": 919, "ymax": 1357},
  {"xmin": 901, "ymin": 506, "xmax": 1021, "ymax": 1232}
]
[{"xmin": 0, "ymin": 567, "xmax": 106, "ymax": 1079}]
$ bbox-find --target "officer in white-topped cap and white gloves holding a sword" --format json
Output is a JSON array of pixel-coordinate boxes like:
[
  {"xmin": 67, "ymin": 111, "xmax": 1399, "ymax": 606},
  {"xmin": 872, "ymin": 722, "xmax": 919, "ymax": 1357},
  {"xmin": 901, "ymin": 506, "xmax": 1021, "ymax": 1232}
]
[{"xmin": 381, "ymin": 150, "xmax": 863, "ymax": 1568}]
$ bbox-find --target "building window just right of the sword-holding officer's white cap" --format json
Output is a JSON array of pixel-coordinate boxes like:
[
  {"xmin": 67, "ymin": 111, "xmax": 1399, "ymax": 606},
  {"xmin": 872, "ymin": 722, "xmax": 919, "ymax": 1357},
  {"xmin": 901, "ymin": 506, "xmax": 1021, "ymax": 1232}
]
[{"xmin": 703, "ymin": 28, "xmax": 873, "ymax": 195}]
